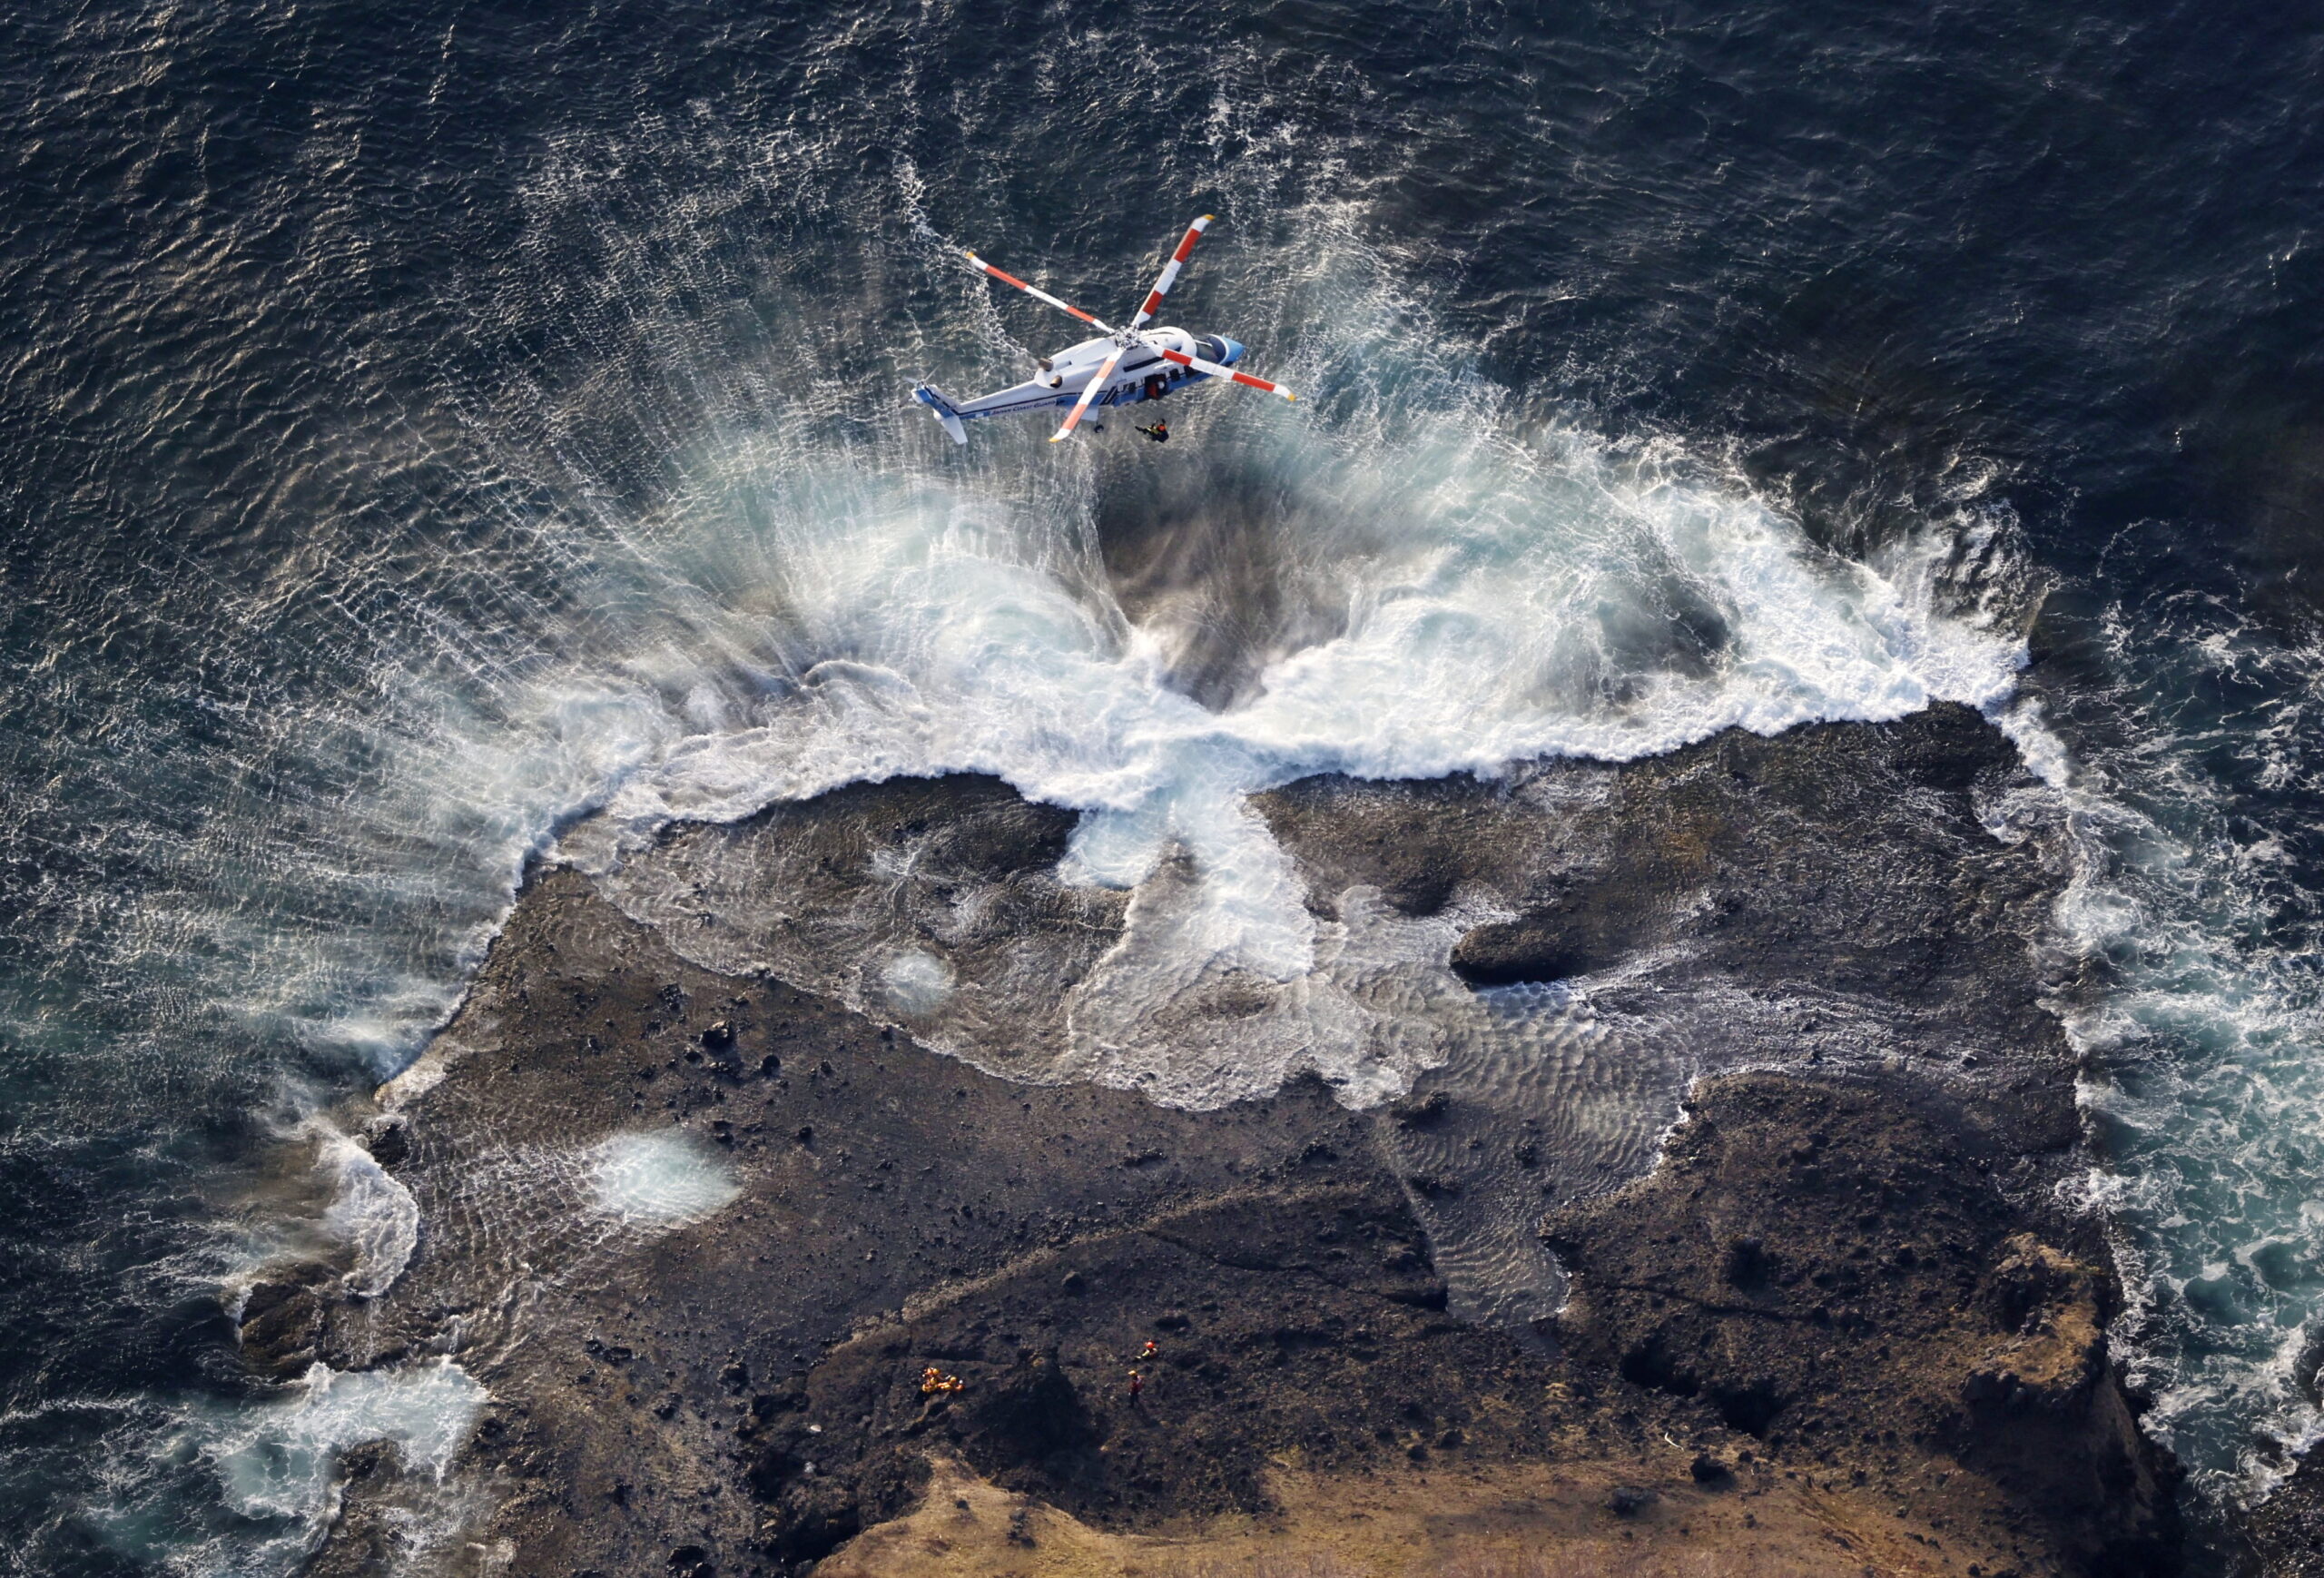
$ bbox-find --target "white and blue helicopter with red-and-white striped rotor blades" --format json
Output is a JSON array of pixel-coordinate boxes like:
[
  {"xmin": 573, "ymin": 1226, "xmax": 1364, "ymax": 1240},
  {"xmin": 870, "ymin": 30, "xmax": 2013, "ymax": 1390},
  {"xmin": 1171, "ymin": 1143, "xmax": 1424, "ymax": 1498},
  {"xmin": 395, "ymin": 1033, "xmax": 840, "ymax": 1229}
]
[{"xmin": 911, "ymin": 213, "xmax": 1296, "ymax": 444}]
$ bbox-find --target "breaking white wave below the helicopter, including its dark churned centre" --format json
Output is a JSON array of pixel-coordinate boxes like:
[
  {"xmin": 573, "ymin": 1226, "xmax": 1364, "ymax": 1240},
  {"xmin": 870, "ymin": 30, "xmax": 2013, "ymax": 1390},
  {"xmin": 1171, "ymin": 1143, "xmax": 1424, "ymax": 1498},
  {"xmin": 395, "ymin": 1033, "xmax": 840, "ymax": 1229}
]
[{"xmin": 480, "ymin": 173, "xmax": 2024, "ymax": 1106}]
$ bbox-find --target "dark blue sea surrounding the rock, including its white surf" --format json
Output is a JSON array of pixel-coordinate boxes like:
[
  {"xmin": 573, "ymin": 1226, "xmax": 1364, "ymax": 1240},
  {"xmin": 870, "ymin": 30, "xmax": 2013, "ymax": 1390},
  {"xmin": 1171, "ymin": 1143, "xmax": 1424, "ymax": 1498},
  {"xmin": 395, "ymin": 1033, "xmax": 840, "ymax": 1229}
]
[{"xmin": 0, "ymin": 0, "xmax": 2324, "ymax": 1573}]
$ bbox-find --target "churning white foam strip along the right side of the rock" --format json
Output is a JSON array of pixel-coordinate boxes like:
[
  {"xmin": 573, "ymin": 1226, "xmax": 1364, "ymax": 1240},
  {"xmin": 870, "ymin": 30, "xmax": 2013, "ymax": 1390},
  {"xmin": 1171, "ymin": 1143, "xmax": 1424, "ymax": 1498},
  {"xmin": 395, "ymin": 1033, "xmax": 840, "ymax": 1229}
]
[{"xmin": 2059, "ymin": 609, "xmax": 2324, "ymax": 1504}]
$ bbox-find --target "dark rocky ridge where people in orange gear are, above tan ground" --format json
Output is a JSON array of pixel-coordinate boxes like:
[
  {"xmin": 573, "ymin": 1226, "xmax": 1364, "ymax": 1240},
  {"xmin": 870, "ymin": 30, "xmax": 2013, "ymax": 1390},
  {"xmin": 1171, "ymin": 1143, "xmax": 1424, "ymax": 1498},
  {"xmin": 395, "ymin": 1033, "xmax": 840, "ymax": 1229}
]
[{"xmin": 734, "ymin": 1171, "xmax": 1573, "ymax": 1543}]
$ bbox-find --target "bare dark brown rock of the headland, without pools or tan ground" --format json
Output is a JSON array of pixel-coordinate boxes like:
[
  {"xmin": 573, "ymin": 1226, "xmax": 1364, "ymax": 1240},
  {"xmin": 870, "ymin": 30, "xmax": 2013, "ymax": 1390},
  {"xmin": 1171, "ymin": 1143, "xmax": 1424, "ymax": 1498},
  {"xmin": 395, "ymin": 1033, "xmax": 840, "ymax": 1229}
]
[{"xmin": 285, "ymin": 709, "xmax": 2173, "ymax": 1578}]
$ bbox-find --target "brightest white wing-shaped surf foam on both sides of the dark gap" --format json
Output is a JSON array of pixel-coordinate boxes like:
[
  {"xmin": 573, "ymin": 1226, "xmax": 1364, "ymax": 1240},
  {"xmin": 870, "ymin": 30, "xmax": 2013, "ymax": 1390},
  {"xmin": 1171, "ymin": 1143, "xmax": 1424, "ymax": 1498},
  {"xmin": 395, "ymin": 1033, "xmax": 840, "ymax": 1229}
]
[{"xmin": 548, "ymin": 386, "xmax": 2022, "ymax": 1104}]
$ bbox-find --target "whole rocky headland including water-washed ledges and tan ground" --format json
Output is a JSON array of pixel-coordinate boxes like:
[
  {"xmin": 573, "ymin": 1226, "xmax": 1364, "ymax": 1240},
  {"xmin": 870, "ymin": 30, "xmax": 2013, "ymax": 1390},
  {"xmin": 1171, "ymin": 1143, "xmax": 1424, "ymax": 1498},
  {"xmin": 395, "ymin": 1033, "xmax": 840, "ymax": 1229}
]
[{"xmin": 244, "ymin": 706, "xmax": 2182, "ymax": 1578}]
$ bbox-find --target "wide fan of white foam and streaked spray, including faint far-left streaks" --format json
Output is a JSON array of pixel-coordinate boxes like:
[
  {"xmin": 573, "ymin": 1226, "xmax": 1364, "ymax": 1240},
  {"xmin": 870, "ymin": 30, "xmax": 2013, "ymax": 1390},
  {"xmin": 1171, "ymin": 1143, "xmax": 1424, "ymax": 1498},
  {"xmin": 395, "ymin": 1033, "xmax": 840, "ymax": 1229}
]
[{"xmin": 82, "ymin": 149, "xmax": 2022, "ymax": 1115}]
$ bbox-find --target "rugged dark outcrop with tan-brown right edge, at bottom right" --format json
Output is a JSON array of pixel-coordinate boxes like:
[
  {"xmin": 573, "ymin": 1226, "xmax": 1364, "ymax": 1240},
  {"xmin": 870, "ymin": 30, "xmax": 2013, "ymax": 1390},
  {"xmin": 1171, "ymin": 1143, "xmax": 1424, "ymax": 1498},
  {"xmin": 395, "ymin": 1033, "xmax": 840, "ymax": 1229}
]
[{"xmin": 1548, "ymin": 1074, "xmax": 2178, "ymax": 1573}]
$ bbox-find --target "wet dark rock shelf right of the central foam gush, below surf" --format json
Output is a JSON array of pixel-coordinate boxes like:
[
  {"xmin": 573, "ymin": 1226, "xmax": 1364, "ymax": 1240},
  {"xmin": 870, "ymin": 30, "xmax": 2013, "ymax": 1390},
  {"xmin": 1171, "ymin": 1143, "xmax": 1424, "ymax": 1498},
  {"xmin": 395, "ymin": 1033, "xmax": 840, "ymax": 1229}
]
[{"xmin": 1255, "ymin": 705, "xmax": 2073, "ymax": 1060}]
